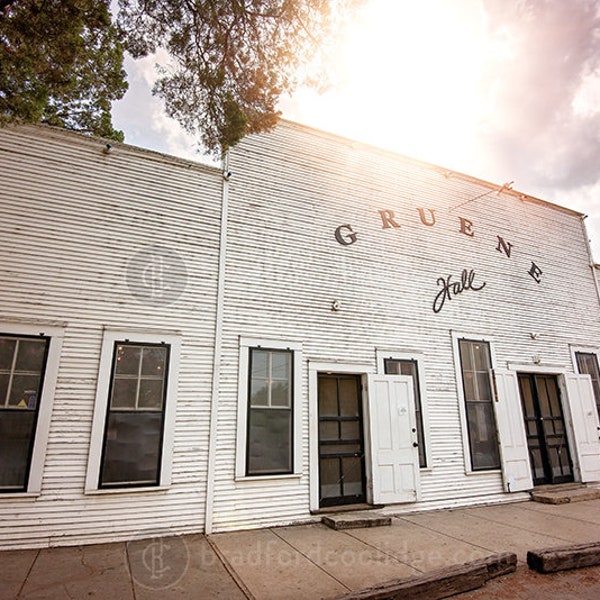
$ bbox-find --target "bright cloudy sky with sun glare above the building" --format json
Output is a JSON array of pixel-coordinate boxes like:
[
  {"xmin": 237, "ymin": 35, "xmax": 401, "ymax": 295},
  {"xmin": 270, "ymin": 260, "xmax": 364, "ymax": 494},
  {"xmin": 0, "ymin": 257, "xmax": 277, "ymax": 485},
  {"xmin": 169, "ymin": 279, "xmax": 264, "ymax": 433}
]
[{"xmin": 113, "ymin": 0, "xmax": 600, "ymax": 262}]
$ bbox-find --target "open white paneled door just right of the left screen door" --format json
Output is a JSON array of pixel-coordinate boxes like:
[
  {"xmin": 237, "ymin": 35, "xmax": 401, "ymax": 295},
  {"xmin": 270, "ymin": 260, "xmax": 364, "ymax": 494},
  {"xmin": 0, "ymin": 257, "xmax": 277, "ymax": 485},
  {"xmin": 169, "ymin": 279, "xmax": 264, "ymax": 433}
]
[{"xmin": 369, "ymin": 375, "xmax": 419, "ymax": 504}]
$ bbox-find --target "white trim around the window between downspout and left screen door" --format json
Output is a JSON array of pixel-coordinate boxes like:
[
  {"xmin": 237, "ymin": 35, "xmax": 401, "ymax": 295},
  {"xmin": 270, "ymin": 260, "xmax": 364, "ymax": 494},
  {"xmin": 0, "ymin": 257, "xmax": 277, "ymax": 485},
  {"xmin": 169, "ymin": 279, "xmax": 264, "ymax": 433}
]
[{"xmin": 235, "ymin": 337, "xmax": 303, "ymax": 482}]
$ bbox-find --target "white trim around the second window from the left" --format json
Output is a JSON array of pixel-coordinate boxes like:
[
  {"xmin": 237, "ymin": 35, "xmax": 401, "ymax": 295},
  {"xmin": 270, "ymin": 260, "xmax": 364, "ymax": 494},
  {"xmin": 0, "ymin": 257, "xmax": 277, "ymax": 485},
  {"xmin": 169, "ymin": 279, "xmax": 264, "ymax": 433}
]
[{"xmin": 85, "ymin": 329, "xmax": 181, "ymax": 494}]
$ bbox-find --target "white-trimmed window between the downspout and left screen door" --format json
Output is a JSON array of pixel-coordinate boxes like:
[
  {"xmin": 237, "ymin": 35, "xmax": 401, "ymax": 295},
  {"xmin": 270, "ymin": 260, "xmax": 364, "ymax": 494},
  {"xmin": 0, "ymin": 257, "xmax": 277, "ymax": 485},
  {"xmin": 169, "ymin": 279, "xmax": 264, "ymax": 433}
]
[{"xmin": 236, "ymin": 338, "xmax": 302, "ymax": 480}]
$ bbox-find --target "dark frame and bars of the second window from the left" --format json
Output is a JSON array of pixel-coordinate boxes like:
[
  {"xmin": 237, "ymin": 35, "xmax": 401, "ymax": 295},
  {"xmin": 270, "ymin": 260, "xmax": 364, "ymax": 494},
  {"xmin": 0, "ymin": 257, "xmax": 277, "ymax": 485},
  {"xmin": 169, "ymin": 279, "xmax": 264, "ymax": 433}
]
[{"xmin": 98, "ymin": 340, "xmax": 172, "ymax": 489}]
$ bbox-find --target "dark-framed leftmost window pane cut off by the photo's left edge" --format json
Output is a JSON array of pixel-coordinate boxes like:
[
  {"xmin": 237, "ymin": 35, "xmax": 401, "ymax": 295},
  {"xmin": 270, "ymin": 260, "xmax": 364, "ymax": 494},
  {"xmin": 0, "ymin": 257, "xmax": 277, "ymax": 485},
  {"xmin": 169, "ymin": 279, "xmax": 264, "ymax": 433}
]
[{"xmin": 0, "ymin": 334, "xmax": 50, "ymax": 492}]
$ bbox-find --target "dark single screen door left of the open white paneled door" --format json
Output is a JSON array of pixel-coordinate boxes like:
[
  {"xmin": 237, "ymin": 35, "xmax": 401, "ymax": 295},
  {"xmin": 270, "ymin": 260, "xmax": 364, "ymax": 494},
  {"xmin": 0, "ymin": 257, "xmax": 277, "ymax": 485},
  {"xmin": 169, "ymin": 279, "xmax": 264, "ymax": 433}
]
[{"xmin": 319, "ymin": 374, "xmax": 366, "ymax": 507}]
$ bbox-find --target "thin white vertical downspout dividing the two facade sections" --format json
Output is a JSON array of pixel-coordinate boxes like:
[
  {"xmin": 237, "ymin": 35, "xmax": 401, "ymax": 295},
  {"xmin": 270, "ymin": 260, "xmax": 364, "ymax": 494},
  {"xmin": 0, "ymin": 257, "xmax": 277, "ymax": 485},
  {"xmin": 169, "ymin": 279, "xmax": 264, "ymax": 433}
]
[{"xmin": 204, "ymin": 151, "xmax": 231, "ymax": 535}]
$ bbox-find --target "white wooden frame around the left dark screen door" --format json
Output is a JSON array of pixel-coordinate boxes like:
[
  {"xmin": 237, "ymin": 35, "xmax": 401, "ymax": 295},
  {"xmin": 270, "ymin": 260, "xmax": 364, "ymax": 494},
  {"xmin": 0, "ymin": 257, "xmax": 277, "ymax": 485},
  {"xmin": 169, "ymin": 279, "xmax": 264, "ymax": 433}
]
[{"xmin": 308, "ymin": 360, "xmax": 375, "ymax": 512}]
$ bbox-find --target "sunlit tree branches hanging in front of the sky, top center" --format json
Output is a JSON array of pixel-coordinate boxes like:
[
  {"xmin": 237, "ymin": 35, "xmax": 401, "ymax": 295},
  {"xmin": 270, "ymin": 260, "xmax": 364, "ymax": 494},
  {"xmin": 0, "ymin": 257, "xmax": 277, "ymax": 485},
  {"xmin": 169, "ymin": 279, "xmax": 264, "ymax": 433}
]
[{"xmin": 119, "ymin": 0, "xmax": 364, "ymax": 154}]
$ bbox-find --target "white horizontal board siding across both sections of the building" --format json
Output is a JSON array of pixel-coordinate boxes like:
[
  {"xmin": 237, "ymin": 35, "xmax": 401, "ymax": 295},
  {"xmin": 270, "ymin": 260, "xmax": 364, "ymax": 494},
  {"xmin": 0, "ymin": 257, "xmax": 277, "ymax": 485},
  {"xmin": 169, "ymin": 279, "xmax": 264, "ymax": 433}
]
[{"xmin": 0, "ymin": 122, "xmax": 600, "ymax": 547}]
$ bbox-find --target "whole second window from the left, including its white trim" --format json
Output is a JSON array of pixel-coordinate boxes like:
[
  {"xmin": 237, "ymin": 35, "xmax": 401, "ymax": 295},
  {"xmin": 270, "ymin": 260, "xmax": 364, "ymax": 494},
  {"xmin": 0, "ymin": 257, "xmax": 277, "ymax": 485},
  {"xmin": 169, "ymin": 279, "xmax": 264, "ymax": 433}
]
[{"xmin": 86, "ymin": 331, "xmax": 181, "ymax": 492}]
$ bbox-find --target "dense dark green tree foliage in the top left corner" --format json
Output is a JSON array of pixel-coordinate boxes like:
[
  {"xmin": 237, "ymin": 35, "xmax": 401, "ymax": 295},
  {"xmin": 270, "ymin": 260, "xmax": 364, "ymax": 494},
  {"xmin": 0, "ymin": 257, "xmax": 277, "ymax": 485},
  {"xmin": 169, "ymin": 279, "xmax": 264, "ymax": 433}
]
[{"xmin": 0, "ymin": 0, "xmax": 127, "ymax": 139}]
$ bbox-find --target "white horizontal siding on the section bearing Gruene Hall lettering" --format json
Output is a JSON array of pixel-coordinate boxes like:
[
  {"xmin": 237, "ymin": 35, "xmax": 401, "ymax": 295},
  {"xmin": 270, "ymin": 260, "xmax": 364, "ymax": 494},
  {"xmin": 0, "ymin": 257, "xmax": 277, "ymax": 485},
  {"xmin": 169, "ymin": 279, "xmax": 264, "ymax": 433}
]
[{"xmin": 210, "ymin": 122, "xmax": 600, "ymax": 530}]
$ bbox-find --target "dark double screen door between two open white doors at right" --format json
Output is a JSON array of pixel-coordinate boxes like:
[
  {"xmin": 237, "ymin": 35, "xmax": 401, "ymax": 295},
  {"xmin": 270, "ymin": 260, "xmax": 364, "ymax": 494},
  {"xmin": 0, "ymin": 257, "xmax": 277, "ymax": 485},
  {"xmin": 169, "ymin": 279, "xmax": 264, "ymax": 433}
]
[{"xmin": 518, "ymin": 373, "xmax": 573, "ymax": 485}]
